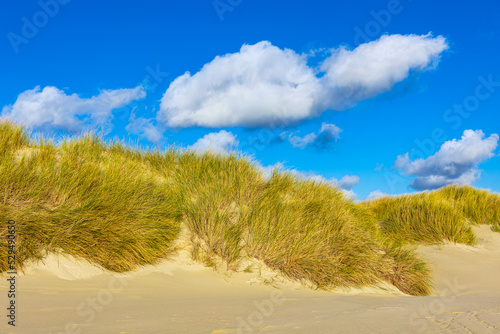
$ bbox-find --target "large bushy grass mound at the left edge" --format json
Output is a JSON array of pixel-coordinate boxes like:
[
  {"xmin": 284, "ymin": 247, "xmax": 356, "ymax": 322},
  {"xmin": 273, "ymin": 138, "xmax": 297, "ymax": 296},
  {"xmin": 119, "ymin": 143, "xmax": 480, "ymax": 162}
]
[{"xmin": 0, "ymin": 124, "xmax": 182, "ymax": 272}]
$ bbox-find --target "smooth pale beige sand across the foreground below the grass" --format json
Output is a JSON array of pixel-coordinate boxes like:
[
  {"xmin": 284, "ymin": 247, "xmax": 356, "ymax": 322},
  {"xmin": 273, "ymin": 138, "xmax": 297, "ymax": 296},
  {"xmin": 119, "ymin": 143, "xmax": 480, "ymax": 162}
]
[{"xmin": 0, "ymin": 226, "xmax": 500, "ymax": 334}]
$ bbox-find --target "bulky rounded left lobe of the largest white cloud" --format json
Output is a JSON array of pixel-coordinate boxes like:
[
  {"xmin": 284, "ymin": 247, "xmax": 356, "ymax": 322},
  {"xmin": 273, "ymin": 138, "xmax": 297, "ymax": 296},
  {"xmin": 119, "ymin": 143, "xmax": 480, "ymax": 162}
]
[{"xmin": 158, "ymin": 41, "xmax": 321, "ymax": 127}]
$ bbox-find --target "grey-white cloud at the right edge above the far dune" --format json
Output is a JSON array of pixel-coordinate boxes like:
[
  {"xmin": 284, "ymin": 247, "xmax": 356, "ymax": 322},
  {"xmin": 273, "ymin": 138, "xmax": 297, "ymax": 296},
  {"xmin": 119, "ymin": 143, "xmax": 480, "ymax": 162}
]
[{"xmin": 394, "ymin": 130, "xmax": 499, "ymax": 190}]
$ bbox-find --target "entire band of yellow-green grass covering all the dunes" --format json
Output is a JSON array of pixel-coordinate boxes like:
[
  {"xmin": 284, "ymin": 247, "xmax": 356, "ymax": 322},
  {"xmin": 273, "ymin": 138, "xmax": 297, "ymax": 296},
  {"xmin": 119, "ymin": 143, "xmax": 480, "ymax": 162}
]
[{"xmin": 0, "ymin": 122, "xmax": 498, "ymax": 295}]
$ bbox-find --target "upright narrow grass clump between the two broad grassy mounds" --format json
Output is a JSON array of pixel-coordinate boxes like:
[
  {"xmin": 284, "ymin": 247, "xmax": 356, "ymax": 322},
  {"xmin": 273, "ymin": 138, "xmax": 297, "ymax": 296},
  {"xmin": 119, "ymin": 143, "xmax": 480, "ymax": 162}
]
[{"xmin": 176, "ymin": 152, "xmax": 265, "ymax": 269}]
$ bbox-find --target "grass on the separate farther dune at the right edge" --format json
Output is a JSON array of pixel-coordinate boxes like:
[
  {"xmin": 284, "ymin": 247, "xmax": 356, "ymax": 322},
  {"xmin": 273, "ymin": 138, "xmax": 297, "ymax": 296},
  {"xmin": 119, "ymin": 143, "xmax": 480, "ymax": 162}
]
[{"xmin": 360, "ymin": 185, "xmax": 500, "ymax": 245}]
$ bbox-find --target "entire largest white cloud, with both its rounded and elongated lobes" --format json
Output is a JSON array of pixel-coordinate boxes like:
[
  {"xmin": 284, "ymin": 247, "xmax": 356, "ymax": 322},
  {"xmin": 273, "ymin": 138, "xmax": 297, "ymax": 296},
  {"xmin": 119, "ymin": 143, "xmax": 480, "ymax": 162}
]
[{"xmin": 157, "ymin": 34, "xmax": 448, "ymax": 128}]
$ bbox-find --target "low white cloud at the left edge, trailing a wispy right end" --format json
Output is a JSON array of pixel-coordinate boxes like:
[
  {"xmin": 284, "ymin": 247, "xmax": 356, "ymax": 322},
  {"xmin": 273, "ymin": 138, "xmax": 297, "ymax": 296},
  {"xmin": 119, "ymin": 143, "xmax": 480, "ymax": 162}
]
[{"xmin": 1, "ymin": 86, "xmax": 146, "ymax": 132}]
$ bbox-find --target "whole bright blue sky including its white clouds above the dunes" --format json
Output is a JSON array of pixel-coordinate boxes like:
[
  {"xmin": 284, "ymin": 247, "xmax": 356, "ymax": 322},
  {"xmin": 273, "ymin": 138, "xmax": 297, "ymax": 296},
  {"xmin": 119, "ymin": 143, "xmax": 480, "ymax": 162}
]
[{"xmin": 0, "ymin": 0, "xmax": 500, "ymax": 199}]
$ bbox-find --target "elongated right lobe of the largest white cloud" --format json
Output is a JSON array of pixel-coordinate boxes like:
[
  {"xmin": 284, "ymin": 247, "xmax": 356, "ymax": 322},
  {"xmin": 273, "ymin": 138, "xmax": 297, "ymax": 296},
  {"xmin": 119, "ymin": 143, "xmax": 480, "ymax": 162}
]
[{"xmin": 321, "ymin": 34, "xmax": 448, "ymax": 109}]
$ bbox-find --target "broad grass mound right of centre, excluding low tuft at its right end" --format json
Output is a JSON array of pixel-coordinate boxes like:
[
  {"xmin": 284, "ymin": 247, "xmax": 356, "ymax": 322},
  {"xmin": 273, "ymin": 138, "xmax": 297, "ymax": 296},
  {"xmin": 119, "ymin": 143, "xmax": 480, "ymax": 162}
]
[{"xmin": 244, "ymin": 173, "xmax": 383, "ymax": 286}]
